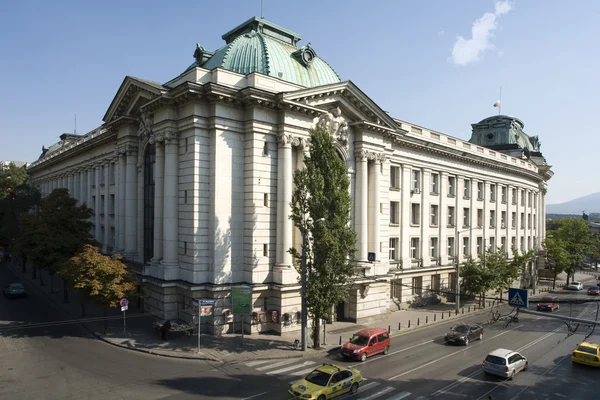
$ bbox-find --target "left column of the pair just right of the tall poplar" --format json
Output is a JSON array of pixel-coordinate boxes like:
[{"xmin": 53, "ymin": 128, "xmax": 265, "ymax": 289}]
[{"xmin": 354, "ymin": 150, "xmax": 369, "ymax": 261}]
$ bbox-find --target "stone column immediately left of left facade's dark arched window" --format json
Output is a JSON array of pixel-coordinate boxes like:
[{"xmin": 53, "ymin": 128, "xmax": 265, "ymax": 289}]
[{"xmin": 124, "ymin": 144, "xmax": 138, "ymax": 259}]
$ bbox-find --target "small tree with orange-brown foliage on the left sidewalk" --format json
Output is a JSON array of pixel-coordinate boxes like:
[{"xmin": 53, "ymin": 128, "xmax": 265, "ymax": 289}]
[{"xmin": 58, "ymin": 244, "xmax": 137, "ymax": 333}]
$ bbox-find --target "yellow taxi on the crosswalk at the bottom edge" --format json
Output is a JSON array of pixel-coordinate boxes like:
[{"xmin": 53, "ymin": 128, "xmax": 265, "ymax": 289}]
[{"xmin": 288, "ymin": 364, "xmax": 363, "ymax": 400}]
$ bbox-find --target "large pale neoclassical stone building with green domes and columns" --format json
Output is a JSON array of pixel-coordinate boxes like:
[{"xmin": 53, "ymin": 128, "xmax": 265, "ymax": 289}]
[{"xmin": 28, "ymin": 18, "xmax": 552, "ymax": 332}]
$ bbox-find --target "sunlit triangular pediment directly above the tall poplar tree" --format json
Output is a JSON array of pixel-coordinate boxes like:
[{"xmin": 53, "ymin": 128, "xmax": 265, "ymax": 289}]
[{"xmin": 283, "ymin": 81, "xmax": 398, "ymax": 131}]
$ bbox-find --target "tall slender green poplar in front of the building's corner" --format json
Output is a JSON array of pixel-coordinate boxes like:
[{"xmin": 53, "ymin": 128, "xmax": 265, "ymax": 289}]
[{"xmin": 289, "ymin": 128, "xmax": 356, "ymax": 348}]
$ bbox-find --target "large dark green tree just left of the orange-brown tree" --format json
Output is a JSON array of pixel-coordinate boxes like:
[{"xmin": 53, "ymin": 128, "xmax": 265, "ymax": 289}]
[{"xmin": 18, "ymin": 189, "xmax": 93, "ymax": 302}]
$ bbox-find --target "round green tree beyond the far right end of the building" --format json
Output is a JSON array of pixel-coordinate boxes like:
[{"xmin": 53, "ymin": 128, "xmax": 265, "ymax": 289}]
[{"xmin": 552, "ymin": 219, "xmax": 598, "ymax": 284}]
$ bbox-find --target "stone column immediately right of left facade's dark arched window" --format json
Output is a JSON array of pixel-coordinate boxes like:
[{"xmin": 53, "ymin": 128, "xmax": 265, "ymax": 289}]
[{"xmin": 150, "ymin": 134, "xmax": 165, "ymax": 263}]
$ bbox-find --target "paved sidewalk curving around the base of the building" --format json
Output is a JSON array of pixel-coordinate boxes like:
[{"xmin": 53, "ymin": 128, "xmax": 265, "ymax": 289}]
[{"xmin": 12, "ymin": 265, "xmax": 596, "ymax": 362}]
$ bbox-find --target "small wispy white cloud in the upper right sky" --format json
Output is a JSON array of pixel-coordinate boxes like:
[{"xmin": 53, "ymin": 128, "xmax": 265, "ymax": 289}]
[{"xmin": 452, "ymin": 1, "xmax": 512, "ymax": 66}]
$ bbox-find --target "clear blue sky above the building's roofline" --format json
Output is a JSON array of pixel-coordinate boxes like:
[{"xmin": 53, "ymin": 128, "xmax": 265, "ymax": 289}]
[{"xmin": 0, "ymin": 0, "xmax": 600, "ymax": 203}]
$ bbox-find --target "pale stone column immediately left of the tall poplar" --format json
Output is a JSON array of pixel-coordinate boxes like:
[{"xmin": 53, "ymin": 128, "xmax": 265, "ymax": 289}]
[{"xmin": 276, "ymin": 134, "xmax": 293, "ymax": 267}]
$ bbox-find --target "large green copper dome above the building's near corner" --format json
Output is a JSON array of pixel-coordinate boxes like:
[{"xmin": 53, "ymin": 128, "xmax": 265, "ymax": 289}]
[{"xmin": 188, "ymin": 17, "xmax": 340, "ymax": 87}]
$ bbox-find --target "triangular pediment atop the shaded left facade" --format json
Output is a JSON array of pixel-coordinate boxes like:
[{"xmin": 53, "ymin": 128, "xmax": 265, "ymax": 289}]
[{"xmin": 102, "ymin": 76, "xmax": 168, "ymax": 123}]
